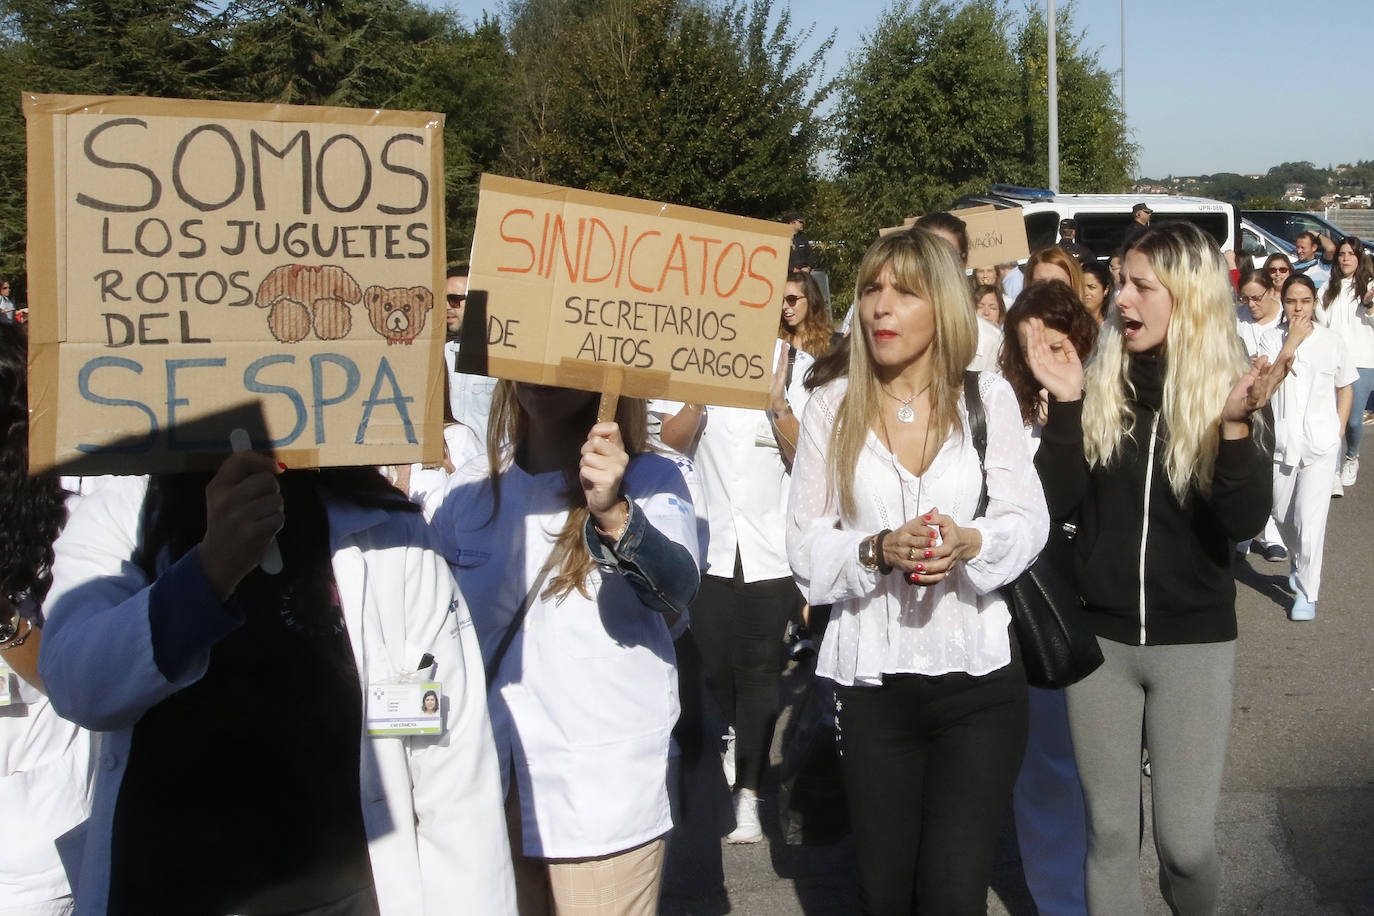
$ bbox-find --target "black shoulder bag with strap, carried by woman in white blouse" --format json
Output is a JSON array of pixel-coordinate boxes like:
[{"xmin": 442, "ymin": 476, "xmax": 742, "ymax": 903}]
[{"xmin": 963, "ymin": 372, "xmax": 1102, "ymax": 689}]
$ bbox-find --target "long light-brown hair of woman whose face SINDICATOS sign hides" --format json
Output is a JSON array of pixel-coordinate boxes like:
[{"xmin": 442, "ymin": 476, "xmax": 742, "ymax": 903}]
[{"xmin": 486, "ymin": 379, "xmax": 649, "ymax": 600}]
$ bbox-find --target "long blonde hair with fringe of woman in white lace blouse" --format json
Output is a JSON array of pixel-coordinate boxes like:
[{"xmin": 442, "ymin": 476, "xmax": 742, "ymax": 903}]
[{"xmin": 826, "ymin": 228, "xmax": 978, "ymax": 516}]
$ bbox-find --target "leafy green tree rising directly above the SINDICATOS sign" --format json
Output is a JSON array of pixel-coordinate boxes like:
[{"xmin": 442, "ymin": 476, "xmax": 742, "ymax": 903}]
[{"xmin": 507, "ymin": 0, "xmax": 830, "ymax": 218}]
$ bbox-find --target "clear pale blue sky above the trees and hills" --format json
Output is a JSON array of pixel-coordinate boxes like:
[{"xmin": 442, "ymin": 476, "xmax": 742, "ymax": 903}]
[{"xmin": 445, "ymin": 0, "xmax": 1374, "ymax": 177}]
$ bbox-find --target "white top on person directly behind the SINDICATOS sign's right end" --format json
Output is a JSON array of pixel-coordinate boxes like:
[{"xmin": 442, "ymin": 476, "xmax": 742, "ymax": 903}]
[{"xmin": 649, "ymin": 341, "xmax": 815, "ymax": 582}]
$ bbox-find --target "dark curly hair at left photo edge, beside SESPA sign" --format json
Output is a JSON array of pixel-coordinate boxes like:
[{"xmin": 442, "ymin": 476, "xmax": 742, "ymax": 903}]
[{"xmin": 0, "ymin": 321, "xmax": 67, "ymax": 602}]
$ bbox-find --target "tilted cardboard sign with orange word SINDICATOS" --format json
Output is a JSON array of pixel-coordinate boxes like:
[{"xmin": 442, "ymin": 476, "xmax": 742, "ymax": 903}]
[{"xmin": 464, "ymin": 174, "xmax": 791, "ymax": 408}]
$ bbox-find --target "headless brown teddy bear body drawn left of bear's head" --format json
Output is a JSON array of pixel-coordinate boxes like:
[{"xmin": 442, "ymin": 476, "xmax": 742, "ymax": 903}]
[{"xmin": 256, "ymin": 264, "xmax": 363, "ymax": 343}]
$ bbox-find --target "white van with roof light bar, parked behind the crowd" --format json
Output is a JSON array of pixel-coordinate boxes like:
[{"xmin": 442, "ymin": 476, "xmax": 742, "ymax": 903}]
[{"xmin": 949, "ymin": 184, "xmax": 1238, "ymax": 261}]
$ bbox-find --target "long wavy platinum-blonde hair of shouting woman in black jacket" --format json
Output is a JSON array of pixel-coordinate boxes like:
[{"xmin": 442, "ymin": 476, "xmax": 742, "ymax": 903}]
[{"xmin": 1083, "ymin": 222, "xmax": 1259, "ymax": 503}]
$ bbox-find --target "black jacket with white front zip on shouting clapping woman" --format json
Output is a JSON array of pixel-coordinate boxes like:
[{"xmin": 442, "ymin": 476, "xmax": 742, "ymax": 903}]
[{"xmin": 1035, "ymin": 356, "xmax": 1274, "ymax": 645}]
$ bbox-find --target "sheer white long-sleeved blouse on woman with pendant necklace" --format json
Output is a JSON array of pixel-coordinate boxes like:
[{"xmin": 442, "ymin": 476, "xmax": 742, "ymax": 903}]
[{"xmin": 787, "ymin": 372, "xmax": 1050, "ymax": 685}]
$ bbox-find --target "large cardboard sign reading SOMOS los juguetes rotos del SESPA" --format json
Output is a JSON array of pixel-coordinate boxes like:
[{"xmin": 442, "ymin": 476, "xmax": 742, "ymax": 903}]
[{"xmin": 23, "ymin": 95, "xmax": 444, "ymax": 474}]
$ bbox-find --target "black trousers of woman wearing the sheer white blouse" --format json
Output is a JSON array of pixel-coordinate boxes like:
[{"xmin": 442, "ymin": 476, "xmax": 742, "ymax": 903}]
[{"xmin": 835, "ymin": 650, "xmax": 1026, "ymax": 916}]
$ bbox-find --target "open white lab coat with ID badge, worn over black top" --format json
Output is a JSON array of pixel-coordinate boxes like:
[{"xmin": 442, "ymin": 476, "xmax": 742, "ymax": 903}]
[{"xmin": 38, "ymin": 478, "xmax": 515, "ymax": 916}]
